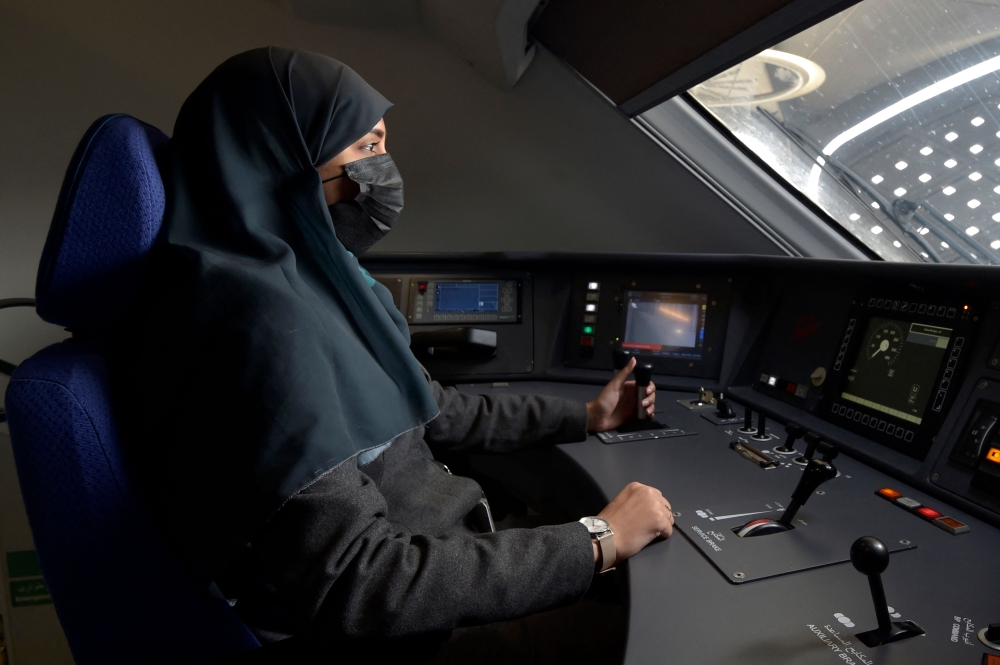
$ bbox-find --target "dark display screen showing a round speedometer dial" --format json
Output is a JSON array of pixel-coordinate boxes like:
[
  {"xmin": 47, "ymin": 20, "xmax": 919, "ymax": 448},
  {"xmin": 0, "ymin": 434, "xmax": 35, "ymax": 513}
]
[{"xmin": 841, "ymin": 317, "xmax": 952, "ymax": 425}]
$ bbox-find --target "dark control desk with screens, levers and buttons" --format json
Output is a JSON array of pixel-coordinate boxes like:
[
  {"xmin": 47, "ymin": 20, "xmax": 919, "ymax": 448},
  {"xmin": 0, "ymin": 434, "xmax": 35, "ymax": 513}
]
[{"xmin": 363, "ymin": 255, "xmax": 1000, "ymax": 664}]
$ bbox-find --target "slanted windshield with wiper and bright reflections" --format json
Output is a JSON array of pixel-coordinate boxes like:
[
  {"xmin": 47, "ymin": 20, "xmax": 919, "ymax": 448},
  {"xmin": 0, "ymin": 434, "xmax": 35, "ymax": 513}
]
[{"xmin": 689, "ymin": 0, "xmax": 1000, "ymax": 265}]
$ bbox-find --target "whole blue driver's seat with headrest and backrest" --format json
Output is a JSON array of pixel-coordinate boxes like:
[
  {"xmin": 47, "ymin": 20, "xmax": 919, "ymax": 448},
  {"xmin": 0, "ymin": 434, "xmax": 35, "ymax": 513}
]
[{"xmin": 6, "ymin": 114, "xmax": 260, "ymax": 665}]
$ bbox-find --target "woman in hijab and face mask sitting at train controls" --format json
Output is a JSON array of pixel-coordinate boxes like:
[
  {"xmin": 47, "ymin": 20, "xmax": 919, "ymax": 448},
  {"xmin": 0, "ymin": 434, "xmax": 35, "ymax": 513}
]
[{"xmin": 121, "ymin": 47, "xmax": 672, "ymax": 651}]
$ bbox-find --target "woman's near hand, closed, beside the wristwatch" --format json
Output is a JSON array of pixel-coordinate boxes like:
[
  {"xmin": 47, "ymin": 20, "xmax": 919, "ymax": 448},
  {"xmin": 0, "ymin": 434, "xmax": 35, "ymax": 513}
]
[{"xmin": 594, "ymin": 483, "xmax": 674, "ymax": 565}]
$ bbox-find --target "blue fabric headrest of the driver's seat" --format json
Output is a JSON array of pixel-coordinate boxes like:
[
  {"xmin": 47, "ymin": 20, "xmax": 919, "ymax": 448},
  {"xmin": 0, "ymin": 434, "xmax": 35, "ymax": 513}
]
[{"xmin": 35, "ymin": 114, "xmax": 168, "ymax": 334}]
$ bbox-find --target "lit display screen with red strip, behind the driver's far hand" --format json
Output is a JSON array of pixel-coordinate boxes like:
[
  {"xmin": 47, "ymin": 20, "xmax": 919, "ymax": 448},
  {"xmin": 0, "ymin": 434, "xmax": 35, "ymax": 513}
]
[{"xmin": 622, "ymin": 291, "xmax": 708, "ymax": 358}]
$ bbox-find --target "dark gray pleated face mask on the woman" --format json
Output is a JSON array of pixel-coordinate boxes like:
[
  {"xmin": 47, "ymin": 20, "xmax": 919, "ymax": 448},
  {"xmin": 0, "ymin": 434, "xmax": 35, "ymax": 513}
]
[{"xmin": 324, "ymin": 153, "xmax": 403, "ymax": 256}]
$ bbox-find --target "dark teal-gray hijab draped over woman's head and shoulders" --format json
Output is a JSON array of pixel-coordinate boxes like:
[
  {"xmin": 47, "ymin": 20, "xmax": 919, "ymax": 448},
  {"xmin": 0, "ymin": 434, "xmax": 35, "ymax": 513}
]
[{"xmin": 120, "ymin": 47, "xmax": 438, "ymax": 582}]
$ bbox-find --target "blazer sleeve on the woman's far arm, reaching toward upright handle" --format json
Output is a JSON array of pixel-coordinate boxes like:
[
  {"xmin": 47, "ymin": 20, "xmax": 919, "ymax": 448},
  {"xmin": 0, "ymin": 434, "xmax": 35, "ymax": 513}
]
[{"xmin": 424, "ymin": 381, "xmax": 587, "ymax": 453}]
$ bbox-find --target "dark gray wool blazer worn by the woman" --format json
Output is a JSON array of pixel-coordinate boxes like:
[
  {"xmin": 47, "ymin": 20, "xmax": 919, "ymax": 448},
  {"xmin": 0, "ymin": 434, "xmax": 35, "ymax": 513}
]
[{"xmin": 217, "ymin": 382, "xmax": 594, "ymax": 642}]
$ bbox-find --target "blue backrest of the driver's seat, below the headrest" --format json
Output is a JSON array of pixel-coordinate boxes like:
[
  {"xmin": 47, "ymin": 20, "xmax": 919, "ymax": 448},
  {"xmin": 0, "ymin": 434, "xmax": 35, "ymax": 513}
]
[{"xmin": 7, "ymin": 341, "xmax": 259, "ymax": 665}]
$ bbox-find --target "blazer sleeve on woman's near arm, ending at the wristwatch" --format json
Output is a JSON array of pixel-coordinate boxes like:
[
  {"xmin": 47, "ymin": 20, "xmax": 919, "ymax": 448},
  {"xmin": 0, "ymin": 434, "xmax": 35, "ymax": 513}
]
[{"xmin": 225, "ymin": 464, "xmax": 594, "ymax": 638}]
